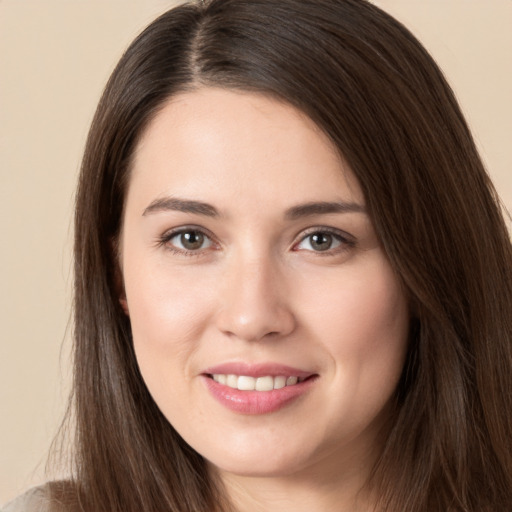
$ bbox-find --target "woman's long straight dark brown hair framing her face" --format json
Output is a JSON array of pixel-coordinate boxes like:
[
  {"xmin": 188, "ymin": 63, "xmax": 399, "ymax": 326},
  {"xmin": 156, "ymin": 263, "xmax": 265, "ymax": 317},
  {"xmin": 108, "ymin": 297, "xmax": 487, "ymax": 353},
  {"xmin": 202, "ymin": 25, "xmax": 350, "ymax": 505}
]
[{"xmin": 57, "ymin": 0, "xmax": 512, "ymax": 512}]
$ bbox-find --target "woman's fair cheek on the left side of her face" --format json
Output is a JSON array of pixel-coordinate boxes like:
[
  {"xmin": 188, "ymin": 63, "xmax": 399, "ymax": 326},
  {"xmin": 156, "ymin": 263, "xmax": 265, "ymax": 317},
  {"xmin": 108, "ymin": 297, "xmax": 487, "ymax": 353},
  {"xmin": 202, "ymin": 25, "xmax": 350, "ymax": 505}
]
[{"xmin": 124, "ymin": 254, "xmax": 216, "ymax": 392}]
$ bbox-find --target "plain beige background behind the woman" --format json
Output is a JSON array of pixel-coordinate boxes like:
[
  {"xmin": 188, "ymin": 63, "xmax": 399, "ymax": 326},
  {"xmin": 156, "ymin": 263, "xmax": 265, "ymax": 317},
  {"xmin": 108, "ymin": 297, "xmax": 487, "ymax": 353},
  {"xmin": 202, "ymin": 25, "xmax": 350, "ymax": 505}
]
[{"xmin": 0, "ymin": 0, "xmax": 512, "ymax": 503}]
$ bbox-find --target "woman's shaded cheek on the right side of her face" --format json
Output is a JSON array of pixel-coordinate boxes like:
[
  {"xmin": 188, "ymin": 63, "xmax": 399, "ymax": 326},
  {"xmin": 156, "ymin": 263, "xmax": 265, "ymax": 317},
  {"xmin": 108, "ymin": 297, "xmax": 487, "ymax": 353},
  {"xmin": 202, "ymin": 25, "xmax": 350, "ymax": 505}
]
[{"xmin": 310, "ymin": 258, "xmax": 409, "ymax": 424}]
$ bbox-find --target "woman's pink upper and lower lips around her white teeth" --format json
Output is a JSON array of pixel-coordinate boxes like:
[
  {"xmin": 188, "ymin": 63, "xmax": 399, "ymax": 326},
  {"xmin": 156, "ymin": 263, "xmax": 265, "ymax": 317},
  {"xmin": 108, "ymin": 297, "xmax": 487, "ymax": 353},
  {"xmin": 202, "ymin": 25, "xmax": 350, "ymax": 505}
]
[{"xmin": 201, "ymin": 363, "xmax": 318, "ymax": 415}]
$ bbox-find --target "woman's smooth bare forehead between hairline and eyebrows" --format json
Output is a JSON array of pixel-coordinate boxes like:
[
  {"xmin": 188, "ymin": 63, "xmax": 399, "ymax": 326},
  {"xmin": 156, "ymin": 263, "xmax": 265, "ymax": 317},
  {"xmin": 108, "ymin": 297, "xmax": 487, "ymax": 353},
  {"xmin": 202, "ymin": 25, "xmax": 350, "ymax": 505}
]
[{"xmin": 128, "ymin": 88, "xmax": 363, "ymax": 212}]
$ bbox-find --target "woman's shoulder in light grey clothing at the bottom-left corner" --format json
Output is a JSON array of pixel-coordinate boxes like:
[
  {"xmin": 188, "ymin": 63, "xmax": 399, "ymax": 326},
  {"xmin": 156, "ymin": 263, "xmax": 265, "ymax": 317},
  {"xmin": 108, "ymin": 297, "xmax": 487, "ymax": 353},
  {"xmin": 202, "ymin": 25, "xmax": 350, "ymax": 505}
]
[{"xmin": 0, "ymin": 481, "xmax": 76, "ymax": 512}]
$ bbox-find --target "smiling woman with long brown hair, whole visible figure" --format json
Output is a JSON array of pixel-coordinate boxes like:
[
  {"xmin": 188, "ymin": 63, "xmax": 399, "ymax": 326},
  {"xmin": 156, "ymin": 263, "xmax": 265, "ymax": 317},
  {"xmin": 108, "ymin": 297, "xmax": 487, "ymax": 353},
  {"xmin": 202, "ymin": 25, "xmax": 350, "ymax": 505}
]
[{"xmin": 5, "ymin": 0, "xmax": 512, "ymax": 512}]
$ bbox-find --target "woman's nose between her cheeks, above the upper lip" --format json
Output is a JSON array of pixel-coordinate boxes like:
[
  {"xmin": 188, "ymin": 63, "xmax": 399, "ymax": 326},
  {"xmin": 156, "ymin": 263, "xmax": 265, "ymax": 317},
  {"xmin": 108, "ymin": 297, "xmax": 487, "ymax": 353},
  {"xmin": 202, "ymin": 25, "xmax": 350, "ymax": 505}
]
[{"xmin": 217, "ymin": 255, "xmax": 296, "ymax": 341}]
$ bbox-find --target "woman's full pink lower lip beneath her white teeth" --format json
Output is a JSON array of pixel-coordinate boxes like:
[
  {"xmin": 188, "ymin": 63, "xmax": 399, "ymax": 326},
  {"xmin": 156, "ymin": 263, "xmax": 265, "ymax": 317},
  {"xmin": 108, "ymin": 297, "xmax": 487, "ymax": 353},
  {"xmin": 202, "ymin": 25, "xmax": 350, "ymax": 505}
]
[{"xmin": 202, "ymin": 375, "xmax": 317, "ymax": 414}]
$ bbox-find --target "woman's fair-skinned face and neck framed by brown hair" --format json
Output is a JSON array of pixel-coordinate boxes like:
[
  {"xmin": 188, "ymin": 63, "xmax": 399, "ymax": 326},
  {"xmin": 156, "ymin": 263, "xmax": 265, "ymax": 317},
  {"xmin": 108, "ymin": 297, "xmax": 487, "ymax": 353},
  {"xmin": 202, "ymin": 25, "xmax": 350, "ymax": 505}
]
[{"xmin": 120, "ymin": 88, "xmax": 408, "ymax": 512}]
